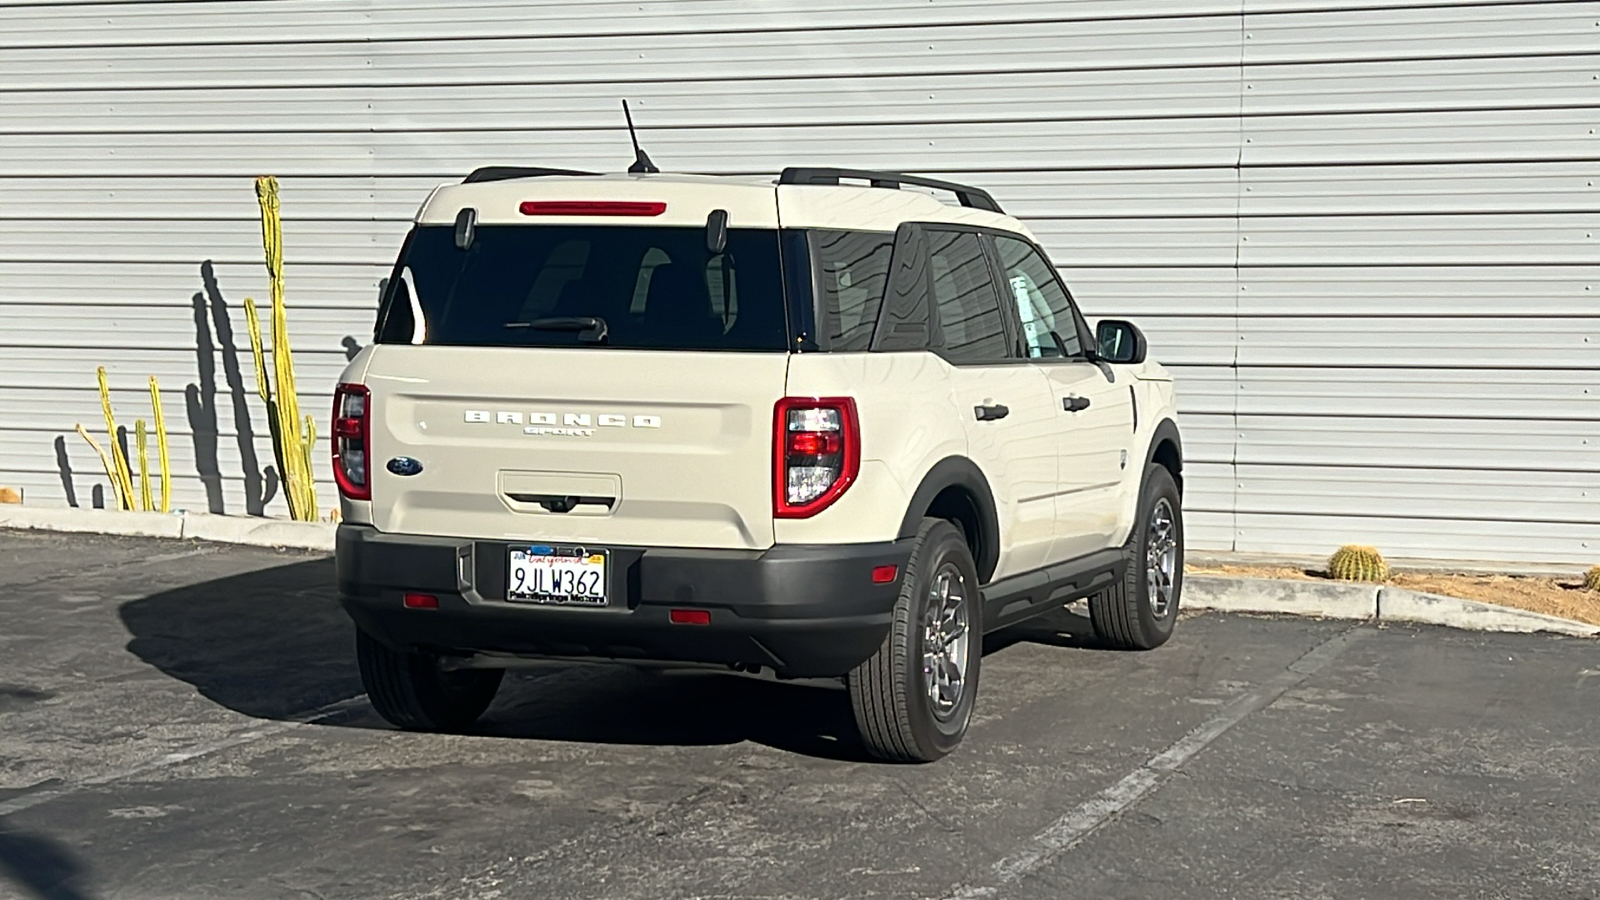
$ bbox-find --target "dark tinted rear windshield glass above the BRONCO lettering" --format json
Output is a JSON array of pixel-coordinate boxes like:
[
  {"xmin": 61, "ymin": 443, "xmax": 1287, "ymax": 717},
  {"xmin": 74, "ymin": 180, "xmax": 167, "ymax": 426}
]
[{"xmin": 378, "ymin": 226, "xmax": 789, "ymax": 351}]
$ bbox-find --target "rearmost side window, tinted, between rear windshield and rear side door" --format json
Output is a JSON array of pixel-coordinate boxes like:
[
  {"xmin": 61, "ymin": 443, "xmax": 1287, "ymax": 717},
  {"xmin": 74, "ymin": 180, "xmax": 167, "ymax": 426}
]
[{"xmin": 813, "ymin": 231, "xmax": 894, "ymax": 351}]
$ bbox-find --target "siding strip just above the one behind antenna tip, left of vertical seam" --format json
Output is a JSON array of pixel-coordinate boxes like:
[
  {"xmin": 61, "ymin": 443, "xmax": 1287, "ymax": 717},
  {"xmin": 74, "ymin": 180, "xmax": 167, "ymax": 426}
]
[{"xmin": 0, "ymin": 18, "xmax": 1238, "ymax": 89}]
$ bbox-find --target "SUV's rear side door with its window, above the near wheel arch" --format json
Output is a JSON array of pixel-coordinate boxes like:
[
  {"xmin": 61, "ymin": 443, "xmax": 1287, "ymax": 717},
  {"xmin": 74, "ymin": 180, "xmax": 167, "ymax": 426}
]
[{"xmin": 926, "ymin": 226, "xmax": 1061, "ymax": 578}]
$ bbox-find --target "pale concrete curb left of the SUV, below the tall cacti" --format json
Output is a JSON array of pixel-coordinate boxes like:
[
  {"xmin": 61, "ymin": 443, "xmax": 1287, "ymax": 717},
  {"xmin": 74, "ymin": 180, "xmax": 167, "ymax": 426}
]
[{"xmin": 0, "ymin": 506, "xmax": 338, "ymax": 552}]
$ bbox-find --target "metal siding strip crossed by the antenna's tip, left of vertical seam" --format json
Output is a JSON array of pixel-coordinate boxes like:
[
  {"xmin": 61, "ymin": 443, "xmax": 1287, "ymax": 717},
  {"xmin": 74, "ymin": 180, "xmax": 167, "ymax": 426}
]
[{"xmin": 0, "ymin": 66, "xmax": 1240, "ymax": 135}]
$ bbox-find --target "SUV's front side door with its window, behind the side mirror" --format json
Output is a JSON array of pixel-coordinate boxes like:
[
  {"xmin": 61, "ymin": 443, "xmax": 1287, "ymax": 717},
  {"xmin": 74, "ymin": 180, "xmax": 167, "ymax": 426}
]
[{"xmin": 994, "ymin": 234, "xmax": 1142, "ymax": 562}]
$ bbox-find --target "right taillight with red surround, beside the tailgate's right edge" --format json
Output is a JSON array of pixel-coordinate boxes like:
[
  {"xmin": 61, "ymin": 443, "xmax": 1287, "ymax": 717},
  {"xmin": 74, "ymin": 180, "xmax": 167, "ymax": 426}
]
[{"xmin": 773, "ymin": 397, "xmax": 861, "ymax": 519}]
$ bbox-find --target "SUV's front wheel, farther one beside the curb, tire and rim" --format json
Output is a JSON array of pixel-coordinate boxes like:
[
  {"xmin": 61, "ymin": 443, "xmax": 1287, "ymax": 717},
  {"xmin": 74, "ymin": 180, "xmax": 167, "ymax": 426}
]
[{"xmin": 1090, "ymin": 463, "xmax": 1184, "ymax": 650}]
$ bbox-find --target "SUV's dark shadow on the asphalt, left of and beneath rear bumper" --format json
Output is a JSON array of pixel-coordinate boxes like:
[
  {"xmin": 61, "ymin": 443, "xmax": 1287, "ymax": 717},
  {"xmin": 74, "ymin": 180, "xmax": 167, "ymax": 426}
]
[{"xmin": 120, "ymin": 559, "xmax": 866, "ymax": 759}]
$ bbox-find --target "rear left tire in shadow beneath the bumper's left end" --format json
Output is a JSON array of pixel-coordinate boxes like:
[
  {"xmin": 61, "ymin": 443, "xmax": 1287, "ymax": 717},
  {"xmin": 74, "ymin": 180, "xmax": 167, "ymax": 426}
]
[{"xmin": 355, "ymin": 631, "xmax": 506, "ymax": 732}]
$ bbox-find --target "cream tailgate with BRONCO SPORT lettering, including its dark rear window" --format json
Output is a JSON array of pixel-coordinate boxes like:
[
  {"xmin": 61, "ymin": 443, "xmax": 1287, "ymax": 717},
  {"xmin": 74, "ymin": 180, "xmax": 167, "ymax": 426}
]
[{"xmin": 366, "ymin": 224, "xmax": 789, "ymax": 548}]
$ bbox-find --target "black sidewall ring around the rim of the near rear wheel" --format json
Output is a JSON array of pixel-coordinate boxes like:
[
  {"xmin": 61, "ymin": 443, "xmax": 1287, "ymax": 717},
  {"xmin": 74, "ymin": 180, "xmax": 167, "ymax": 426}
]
[{"xmin": 901, "ymin": 522, "xmax": 982, "ymax": 757}]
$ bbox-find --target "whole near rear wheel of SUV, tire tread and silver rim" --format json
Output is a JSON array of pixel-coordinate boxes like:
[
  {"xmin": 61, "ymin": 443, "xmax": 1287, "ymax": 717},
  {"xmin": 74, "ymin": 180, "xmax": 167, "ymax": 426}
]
[{"xmin": 845, "ymin": 519, "xmax": 984, "ymax": 762}]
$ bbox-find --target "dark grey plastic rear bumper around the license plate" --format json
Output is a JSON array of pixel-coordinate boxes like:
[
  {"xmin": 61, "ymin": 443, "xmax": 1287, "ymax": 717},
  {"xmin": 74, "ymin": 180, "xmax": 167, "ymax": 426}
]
[{"xmin": 336, "ymin": 525, "xmax": 912, "ymax": 677}]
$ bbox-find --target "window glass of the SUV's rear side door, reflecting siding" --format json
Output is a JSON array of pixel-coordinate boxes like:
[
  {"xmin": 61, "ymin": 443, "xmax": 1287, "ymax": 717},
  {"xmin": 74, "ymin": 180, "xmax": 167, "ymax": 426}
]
[{"xmin": 928, "ymin": 231, "xmax": 1011, "ymax": 362}]
